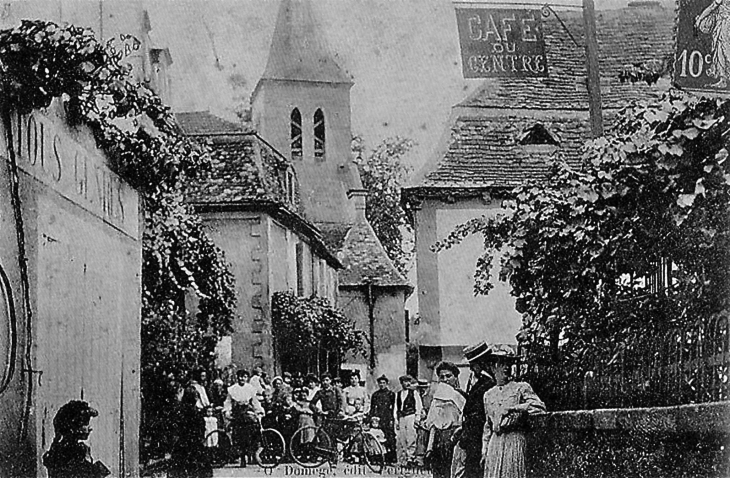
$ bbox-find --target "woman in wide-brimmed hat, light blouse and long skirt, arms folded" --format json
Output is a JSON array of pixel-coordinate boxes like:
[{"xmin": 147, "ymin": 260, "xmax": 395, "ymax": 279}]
[{"xmin": 482, "ymin": 345, "xmax": 545, "ymax": 478}]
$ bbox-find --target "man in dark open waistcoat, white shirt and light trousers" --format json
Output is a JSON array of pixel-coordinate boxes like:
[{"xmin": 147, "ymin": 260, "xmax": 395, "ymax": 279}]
[{"xmin": 393, "ymin": 375, "xmax": 423, "ymax": 466}]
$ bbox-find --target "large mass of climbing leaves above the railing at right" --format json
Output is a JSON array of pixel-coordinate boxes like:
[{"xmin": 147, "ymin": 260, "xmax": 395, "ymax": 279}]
[{"xmin": 435, "ymin": 93, "xmax": 730, "ymax": 363}]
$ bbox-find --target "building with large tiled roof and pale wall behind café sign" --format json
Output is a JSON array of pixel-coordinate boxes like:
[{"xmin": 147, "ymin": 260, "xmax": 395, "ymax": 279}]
[{"xmin": 403, "ymin": 2, "xmax": 674, "ymax": 377}]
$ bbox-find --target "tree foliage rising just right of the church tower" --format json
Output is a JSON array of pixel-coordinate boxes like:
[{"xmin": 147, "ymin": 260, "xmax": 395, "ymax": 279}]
[{"xmin": 352, "ymin": 136, "xmax": 414, "ymax": 274}]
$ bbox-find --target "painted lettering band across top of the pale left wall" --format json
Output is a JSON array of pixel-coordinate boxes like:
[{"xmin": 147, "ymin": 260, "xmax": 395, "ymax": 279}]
[{"xmin": 11, "ymin": 106, "xmax": 139, "ymax": 239}]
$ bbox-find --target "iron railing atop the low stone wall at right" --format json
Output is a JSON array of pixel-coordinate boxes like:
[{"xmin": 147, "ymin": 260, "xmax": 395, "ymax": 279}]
[{"xmin": 516, "ymin": 316, "xmax": 730, "ymax": 410}]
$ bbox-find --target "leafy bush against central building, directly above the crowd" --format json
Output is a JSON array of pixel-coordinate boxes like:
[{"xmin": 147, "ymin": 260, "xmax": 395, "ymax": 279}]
[{"xmin": 271, "ymin": 291, "xmax": 365, "ymax": 374}]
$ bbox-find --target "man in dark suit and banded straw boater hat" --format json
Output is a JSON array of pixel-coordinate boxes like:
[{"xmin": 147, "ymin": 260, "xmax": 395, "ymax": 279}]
[{"xmin": 453, "ymin": 341, "xmax": 494, "ymax": 478}]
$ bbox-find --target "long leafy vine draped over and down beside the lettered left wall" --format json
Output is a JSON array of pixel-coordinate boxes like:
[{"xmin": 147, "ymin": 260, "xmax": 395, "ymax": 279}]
[{"xmin": 0, "ymin": 21, "xmax": 235, "ymax": 460}]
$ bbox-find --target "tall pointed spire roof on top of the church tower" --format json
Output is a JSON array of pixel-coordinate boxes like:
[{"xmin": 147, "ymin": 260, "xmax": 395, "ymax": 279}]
[{"xmin": 261, "ymin": 0, "xmax": 353, "ymax": 84}]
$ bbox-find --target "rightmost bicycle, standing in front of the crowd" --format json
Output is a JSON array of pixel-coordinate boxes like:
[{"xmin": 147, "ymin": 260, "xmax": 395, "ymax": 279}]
[{"xmin": 289, "ymin": 416, "xmax": 385, "ymax": 473}]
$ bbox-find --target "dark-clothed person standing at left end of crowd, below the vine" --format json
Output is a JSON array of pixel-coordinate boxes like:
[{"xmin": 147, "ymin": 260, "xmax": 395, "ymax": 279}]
[{"xmin": 169, "ymin": 387, "xmax": 213, "ymax": 478}]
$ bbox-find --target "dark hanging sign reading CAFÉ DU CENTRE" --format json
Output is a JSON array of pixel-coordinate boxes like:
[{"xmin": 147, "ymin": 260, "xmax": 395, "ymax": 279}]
[{"xmin": 456, "ymin": 8, "xmax": 548, "ymax": 78}]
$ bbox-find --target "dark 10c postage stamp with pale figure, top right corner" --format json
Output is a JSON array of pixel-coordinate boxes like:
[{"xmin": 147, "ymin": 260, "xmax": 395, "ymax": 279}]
[{"xmin": 674, "ymin": 0, "xmax": 730, "ymax": 94}]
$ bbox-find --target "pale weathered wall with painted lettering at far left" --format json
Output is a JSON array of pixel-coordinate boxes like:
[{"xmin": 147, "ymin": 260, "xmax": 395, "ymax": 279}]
[{"xmin": 0, "ymin": 103, "xmax": 142, "ymax": 476}]
